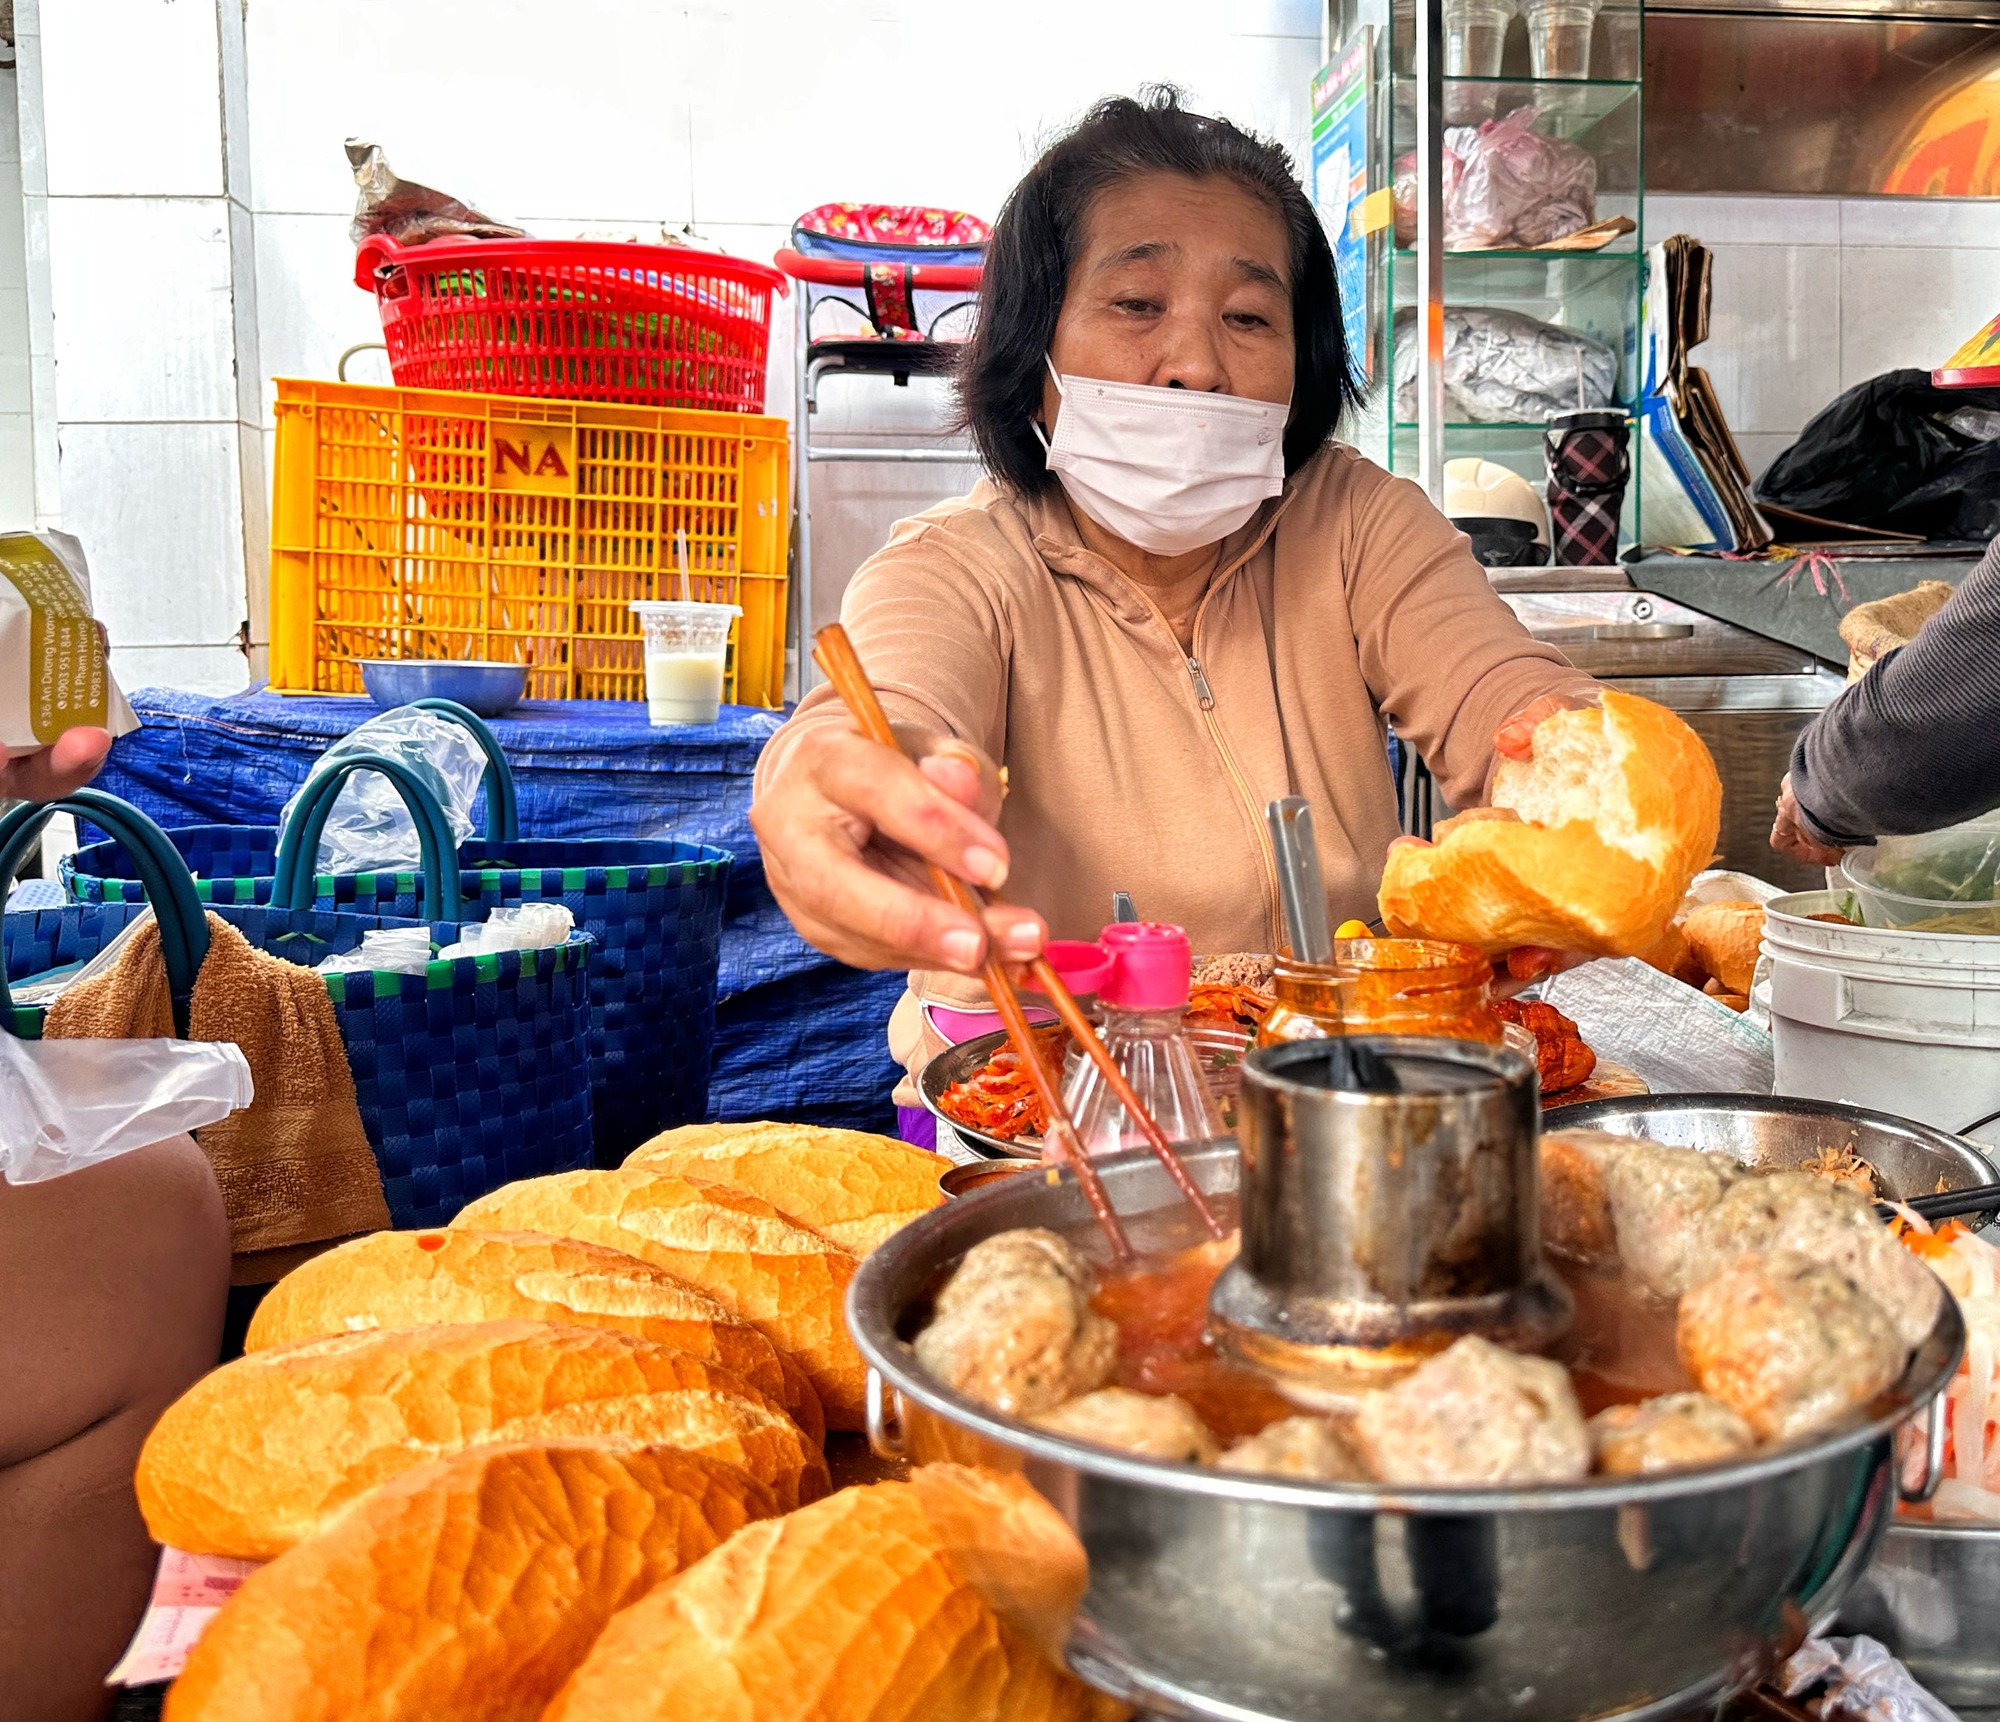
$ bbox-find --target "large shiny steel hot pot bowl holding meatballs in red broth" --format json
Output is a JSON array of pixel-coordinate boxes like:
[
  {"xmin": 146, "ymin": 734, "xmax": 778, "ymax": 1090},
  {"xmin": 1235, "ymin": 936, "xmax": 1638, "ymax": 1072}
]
[{"xmin": 848, "ymin": 1144, "xmax": 1962, "ymax": 1722}]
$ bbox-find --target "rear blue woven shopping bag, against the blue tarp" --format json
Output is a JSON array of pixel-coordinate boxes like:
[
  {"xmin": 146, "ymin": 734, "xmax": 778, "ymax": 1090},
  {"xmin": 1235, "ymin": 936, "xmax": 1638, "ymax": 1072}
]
[{"xmin": 62, "ymin": 700, "xmax": 730, "ymax": 1166}]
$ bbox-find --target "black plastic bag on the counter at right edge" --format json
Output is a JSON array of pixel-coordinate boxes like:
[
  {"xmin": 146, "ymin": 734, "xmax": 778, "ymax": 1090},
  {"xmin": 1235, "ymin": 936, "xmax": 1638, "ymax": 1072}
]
[{"xmin": 1756, "ymin": 370, "xmax": 2000, "ymax": 520}]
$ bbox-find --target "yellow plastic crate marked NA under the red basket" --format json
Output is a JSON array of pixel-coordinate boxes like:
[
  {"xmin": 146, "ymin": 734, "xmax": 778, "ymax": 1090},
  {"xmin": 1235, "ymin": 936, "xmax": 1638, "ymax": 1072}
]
[{"xmin": 270, "ymin": 376, "xmax": 792, "ymax": 706}]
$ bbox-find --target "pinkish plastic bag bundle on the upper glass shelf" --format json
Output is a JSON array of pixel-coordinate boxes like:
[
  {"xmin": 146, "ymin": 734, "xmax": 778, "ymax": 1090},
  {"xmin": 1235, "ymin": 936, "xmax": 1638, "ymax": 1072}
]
[{"xmin": 1394, "ymin": 108, "xmax": 1598, "ymax": 252}]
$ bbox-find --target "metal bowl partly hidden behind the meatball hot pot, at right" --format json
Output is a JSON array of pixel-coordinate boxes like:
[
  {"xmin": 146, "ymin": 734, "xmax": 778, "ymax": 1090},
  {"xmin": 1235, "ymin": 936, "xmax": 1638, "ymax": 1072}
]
[{"xmin": 1542, "ymin": 1094, "xmax": 2000, "ymax": 1200}]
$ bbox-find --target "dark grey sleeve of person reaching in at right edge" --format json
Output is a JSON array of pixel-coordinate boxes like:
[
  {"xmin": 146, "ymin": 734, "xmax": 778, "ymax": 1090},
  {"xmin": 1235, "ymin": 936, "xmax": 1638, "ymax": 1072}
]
[{"xmin": 1792, "ymin": 540, "xmax": 2000, "ymax": 846}]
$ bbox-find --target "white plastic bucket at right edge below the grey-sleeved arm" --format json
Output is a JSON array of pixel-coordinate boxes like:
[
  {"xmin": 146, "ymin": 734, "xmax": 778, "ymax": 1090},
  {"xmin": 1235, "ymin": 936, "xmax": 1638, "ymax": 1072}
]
[{"xmin": 1764, "ymin": 890, "xmax": 2000, "ymax": 1134}]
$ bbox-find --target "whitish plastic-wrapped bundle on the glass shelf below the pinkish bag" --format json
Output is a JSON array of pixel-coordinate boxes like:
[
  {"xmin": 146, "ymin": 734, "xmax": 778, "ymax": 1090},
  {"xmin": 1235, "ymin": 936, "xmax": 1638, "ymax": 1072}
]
[{"xmin": 1396, "ymin": 306, "xmax": 1618, "ymax": 424}]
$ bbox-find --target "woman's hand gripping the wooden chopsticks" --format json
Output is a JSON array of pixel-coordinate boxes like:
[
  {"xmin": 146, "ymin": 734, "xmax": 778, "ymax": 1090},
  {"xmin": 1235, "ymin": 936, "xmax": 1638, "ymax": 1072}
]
[{"xmin": 750, "ymin": 724, "xmax": 1048, "ymax": 974}]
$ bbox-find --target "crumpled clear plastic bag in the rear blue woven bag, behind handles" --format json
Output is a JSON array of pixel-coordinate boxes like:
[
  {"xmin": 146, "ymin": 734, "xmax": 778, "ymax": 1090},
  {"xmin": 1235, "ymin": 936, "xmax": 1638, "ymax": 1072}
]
[{"xmin": 280, "ymin": 706, "xmax": 486, "ymax": 872}]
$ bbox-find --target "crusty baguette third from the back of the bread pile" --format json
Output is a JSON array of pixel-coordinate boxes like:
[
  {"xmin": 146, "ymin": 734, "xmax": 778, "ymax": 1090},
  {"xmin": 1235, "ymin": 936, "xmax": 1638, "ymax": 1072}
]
[{"xmin": 244, "ymin": 1232, "xmax": 826, "ymax": 1444}]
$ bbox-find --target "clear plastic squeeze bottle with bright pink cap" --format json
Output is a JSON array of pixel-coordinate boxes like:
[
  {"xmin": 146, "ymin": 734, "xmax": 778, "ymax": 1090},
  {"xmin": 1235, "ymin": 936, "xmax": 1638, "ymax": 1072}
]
[{"xmin": 1062, "ymin": 920, "xmax": 1224, "ymax": 1158}]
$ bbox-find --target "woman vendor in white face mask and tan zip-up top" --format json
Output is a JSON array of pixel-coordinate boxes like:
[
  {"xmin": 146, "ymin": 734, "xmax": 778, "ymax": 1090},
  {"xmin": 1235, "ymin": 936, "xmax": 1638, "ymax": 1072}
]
[{"xmin": 752, "ymin": 92, "xmax": 1594, "ymax": 1080}]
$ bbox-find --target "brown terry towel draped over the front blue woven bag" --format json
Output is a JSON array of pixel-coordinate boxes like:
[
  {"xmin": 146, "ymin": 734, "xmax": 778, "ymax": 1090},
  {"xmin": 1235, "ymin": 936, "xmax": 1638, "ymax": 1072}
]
[{"xmin": 44, "ymin": 914, "xmax": 390, "ymax": 1284}]
